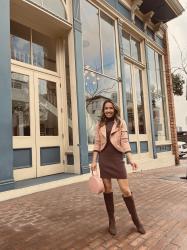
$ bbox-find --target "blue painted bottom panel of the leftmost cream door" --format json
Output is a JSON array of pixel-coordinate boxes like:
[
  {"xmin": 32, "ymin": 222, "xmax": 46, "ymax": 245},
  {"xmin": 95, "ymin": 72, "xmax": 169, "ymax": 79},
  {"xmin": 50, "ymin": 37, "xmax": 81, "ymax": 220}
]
[{"xmin": 13, "ymin": 148, "xmax": 32, "ymax": 169}]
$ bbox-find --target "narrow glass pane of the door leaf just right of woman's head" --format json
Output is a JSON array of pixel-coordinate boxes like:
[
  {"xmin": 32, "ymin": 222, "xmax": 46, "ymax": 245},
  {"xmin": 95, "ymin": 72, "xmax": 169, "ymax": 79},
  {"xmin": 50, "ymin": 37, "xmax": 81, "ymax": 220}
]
[{"xmin": 125, "ymin": 63, "xmax": 135, "ymax": 134}]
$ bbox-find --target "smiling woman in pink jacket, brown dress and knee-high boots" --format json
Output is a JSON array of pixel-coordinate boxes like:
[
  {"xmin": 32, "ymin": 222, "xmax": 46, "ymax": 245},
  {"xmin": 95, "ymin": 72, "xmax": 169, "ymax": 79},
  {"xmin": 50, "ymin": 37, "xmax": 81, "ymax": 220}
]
[{"xmin": 91, "ymin": 100, "xmax": 145, "ymax": 235}]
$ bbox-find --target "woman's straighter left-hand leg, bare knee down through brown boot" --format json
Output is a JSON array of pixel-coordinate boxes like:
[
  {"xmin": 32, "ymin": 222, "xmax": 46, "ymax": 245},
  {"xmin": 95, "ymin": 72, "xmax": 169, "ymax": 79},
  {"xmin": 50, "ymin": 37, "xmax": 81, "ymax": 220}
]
[{"xmin": 103, "ymin": 179, "xmax": 116, "ymax": 235}]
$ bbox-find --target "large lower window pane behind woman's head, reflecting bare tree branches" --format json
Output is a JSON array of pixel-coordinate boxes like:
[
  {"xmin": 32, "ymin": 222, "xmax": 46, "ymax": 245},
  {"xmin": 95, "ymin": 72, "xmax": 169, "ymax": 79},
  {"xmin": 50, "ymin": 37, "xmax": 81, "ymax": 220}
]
[{"xmin": 85, "ymin": 71, "xmax": 119, "ymax": 144}]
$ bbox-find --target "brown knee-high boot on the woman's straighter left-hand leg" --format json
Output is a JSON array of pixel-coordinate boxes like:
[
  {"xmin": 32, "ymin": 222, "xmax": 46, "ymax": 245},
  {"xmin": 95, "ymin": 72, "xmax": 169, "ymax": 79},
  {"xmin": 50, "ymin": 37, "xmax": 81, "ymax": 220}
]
[{"xmin": 103, "ymin": 192, "xmax": 116, "ymax": 235}]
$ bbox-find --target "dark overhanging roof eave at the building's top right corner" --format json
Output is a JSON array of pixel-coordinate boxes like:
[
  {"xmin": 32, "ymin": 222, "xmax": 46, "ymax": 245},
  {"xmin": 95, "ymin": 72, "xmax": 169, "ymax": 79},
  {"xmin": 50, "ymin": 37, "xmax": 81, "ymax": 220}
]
[{"xmin": 140, "ymin": 0, "xmax": 184, "ymax": 24}]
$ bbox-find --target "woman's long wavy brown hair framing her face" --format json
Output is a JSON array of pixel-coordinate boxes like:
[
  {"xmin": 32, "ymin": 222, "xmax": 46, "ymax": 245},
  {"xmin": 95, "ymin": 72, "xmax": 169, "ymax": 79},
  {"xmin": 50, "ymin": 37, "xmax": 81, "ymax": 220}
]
[{"xmin": 99, "ymin": 99, "xmax": 121, "ymax": 127}]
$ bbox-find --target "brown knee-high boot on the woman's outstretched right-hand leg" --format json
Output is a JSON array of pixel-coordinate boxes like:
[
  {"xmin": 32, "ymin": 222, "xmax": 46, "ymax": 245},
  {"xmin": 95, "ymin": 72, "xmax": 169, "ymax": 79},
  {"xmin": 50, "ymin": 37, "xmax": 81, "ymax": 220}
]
[{"xmin": 122, "ymin": 195, "xmax": 145, "ymax": 234}]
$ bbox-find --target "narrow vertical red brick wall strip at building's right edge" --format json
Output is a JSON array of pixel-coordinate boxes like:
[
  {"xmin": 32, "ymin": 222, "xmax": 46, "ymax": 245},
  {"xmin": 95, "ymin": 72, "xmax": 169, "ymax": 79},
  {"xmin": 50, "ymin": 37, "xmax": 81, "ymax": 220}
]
[{"xmin": 164, "ymin": 31, "xmax": 180, "ymax": 165}]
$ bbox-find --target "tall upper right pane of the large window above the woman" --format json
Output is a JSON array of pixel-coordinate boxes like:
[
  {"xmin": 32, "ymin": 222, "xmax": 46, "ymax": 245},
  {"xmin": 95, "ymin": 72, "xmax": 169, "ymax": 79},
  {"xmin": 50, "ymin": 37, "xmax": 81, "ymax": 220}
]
[{"xmin": 101, "ymin": 13, "xmax": 117, "ymax": 77}]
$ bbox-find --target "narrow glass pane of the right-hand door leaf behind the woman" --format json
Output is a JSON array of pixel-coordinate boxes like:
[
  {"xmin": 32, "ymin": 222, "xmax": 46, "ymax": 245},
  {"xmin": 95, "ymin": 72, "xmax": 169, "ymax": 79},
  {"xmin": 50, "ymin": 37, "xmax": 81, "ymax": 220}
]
[{"xmin": 135, "ymin": 68, "xmax": 146, "ymax": 134}]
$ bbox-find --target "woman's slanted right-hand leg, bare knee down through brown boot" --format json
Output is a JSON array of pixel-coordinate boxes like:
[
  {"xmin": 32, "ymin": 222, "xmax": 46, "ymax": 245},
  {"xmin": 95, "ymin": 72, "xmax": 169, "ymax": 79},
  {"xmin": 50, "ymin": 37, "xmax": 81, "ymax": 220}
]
[{"xmin": 118, "ymin": 179, "xmax": 145, "ymax": 234}]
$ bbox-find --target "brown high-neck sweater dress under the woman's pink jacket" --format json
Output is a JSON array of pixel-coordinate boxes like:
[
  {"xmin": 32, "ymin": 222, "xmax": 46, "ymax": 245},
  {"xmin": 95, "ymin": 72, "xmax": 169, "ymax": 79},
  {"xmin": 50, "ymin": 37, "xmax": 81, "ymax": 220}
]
[{"xmin": 99, "ymin": 119, "xmax": 127, "ymax": 179}]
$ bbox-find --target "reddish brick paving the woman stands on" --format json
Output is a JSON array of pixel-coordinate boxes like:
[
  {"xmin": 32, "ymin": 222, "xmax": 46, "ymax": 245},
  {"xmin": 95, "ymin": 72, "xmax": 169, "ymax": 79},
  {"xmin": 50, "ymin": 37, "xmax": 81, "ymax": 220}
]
[{"xmin": 0, "ymin": 159, "xmax": 187, "ymax": 250}]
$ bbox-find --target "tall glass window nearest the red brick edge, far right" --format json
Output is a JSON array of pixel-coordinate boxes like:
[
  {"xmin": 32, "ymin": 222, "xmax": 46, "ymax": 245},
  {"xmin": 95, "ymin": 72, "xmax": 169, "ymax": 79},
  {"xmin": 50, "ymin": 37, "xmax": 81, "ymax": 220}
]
[{"xmin": 147, "ymin": 47, "xmax": 168, "ymax": 141}]
